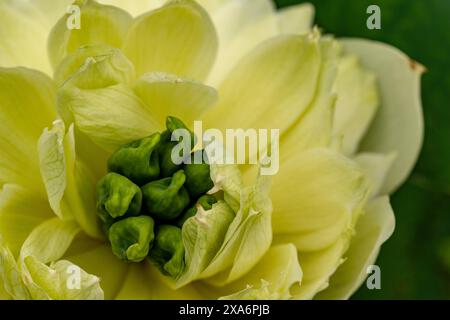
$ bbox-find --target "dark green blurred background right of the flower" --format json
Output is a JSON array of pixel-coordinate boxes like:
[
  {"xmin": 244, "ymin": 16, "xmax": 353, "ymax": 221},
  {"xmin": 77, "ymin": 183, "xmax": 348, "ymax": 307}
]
[{"xmin": 275, "ymin": 0, "xmax": 450, "ymax": 299}]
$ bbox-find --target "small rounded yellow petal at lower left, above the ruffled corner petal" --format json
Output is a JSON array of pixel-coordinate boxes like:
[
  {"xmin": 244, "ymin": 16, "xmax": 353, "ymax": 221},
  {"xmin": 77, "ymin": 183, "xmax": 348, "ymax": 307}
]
[{"xmin": 20, "ymin": 218, "xmax": 80, "ymax": 263}]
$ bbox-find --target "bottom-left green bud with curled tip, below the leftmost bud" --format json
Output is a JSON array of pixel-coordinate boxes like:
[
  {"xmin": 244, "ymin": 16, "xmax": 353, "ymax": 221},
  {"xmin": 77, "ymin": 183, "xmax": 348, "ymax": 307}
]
[{"xmin": 109, "ymin": 216, "xmax": 155, "ymax": 262}]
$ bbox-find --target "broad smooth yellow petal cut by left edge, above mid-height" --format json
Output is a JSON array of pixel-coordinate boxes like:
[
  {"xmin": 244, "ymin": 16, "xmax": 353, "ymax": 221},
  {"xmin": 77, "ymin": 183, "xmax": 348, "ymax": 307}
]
[{"xmin": 0, "ymin": 68, "xmax": 55, "ymax": 192}]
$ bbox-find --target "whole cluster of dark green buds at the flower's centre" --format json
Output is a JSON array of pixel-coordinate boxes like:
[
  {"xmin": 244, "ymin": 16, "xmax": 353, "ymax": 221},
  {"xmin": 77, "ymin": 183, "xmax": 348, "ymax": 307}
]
[{"xmin": 97, "ymin": 117, "xmax": 217, "ymax": 278}]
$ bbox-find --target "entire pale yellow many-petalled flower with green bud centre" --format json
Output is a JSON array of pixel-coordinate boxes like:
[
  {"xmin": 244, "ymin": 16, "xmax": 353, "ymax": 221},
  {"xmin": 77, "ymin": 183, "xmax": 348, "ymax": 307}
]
[{"xmin": 0, "ymin": 0, "xmax": 423, "ymax": 299}]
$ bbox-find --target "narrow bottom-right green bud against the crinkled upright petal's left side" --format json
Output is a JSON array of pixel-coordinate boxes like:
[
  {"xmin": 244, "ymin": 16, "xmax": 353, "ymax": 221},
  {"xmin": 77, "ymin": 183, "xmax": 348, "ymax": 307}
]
[{"xmin": 149, "ymin": 225, "xmax": 184, "ymax": 279}]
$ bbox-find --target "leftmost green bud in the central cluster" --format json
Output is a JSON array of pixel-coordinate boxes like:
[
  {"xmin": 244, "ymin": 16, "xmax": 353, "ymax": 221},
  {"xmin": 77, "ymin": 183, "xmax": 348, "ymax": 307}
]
[{"xmin": 97, "ymin": 173, "xmax": 142, "ymax": 225}]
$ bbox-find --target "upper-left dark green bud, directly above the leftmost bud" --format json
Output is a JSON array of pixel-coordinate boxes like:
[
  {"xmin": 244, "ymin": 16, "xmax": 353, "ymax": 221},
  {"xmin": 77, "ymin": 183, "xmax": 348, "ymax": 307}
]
[{"xmin": 108, "ymin": 133, "xmax": 160, "ymax": 186}]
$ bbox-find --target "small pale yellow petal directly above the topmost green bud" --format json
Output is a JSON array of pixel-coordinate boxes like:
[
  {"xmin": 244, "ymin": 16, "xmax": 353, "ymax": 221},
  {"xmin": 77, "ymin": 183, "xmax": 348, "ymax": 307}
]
[{"xmin": 135, "ymin": 72, "xmax": 218, "ymax": 126}]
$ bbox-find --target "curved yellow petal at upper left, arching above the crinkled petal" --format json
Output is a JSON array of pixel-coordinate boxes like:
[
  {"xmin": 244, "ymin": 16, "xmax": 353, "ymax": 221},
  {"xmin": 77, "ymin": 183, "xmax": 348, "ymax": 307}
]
[{"xmin": 48, "ymin": 0, "xmax": 132, "ymax": 67}]
